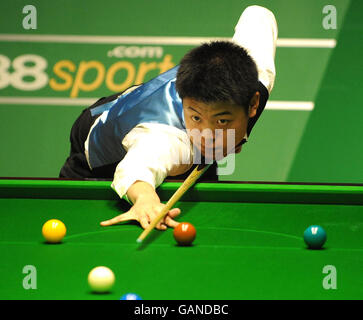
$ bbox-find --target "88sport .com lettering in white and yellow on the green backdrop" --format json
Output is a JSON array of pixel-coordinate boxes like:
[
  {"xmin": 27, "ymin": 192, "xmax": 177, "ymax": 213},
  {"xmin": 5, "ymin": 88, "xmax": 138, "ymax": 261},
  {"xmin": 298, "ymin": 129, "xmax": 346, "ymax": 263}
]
[{"xmin": 0, "ymin": 46, "xmax": 176, "ymax": 98}]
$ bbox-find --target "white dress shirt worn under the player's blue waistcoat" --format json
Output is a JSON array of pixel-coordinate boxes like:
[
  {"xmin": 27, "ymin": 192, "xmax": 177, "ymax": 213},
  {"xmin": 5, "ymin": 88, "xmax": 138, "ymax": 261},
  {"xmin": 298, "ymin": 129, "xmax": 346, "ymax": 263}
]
[{"xmin": 85, "ymin": 6, "xmax": 277, "ymax": 198}]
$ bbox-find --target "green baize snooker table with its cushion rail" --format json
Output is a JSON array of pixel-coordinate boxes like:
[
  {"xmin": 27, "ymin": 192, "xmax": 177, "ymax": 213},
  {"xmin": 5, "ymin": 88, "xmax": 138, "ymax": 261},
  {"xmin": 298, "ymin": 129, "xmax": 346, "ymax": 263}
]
[{"xmin": 0, "ymin": 179, "xmax": 363, "ymax": 300}]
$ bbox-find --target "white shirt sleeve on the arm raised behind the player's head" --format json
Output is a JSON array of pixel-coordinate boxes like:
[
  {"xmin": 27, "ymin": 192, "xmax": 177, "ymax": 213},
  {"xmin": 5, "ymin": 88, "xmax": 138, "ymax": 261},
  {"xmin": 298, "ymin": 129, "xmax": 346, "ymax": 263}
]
[{"xmin": 232, "ymin": 6, "xmax": 278, "ymax": 93}]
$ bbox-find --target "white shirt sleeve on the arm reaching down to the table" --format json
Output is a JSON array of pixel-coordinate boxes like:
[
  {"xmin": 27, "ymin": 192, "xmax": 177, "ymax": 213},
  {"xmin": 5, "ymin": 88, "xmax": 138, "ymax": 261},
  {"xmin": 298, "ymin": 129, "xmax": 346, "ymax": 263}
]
[{"xmin": 111, "ymin": 124, "xmax": 193, "ymax": 198}]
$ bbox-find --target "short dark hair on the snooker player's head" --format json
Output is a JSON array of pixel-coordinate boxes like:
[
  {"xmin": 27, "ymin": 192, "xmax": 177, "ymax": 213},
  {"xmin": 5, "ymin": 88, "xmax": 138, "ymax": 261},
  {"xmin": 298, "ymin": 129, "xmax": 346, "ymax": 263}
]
[{"xmin": 176, "ymin": 41, "xmax": 258, "ymax": 112}]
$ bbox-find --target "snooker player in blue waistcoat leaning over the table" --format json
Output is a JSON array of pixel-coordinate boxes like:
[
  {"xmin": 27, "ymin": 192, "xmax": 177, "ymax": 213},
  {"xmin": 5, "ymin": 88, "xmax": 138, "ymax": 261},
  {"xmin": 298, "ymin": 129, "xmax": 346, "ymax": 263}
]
[{"xmin": 60, "ymin": 6, "xmax": 277, "ymax": 230}]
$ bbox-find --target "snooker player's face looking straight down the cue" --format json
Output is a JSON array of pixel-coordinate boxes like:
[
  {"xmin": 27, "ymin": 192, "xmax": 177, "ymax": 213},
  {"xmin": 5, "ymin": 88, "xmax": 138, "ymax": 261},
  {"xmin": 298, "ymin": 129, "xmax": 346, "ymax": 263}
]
[{"xmin": 183, "ymin": 93, "xmax": 259, "ymax": 160}]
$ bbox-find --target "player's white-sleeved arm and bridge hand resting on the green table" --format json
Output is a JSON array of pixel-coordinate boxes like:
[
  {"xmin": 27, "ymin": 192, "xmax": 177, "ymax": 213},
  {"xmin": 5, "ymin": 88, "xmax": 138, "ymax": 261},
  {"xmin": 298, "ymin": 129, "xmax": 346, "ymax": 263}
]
[{"xmin": 101, "ymin": 126, "xmax": 192, "ymax": 230}]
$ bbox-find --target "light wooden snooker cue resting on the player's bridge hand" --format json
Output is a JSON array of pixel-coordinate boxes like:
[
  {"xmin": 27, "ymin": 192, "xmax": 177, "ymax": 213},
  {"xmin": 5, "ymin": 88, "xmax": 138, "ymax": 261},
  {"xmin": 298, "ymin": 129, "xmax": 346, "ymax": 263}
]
[{"xmin": 136, "ymin": 165, "xmax": 210, "ymax": 243}]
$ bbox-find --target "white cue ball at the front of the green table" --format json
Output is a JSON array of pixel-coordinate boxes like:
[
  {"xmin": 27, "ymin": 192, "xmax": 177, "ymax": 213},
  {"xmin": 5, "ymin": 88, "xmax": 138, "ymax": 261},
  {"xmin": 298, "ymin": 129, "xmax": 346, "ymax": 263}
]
[{"xmin": 88, "ymin": 266, "xmax": 115, "ymax": 293}]
